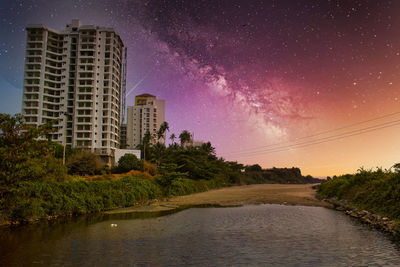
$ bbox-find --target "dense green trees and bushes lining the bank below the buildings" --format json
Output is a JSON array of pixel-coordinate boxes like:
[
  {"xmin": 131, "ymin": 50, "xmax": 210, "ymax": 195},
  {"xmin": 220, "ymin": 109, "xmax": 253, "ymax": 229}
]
[{"xmin": 0, "ymin": 114, "xmax": 316, "ymax": 224}]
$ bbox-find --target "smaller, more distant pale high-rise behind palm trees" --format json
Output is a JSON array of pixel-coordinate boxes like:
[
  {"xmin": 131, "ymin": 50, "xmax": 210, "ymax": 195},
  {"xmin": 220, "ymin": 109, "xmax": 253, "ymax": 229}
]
[{"xmin": 126, "ymin": 94, "xmax": 165, "ymax": 149}]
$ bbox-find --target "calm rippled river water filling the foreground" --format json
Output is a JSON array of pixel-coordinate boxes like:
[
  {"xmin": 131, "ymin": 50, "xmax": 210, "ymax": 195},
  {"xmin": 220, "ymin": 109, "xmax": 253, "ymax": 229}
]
[{"xmin": 0, "ymin": 205, "xmax": 400, "ymax": 266}]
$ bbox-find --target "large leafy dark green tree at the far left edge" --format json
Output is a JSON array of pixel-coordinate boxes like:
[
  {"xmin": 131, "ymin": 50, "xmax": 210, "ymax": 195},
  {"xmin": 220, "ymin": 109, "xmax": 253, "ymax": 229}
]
[{"xmin": 0, "ymin": 113, "xmax": 66, "ymax": 186}]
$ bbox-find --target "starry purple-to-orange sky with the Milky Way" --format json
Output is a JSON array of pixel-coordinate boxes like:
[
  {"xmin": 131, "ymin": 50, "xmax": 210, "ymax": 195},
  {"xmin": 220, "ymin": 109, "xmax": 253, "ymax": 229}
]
[{"xmin": 0, "ymin": 0, "xmax": 400, "ymax": 177}]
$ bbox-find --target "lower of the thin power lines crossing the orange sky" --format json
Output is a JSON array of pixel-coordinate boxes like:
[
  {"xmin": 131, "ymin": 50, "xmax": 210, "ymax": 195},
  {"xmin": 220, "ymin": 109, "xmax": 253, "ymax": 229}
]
[{"xmin": 228, "ymin": 120, "xmax": 400, "ymax": 157}]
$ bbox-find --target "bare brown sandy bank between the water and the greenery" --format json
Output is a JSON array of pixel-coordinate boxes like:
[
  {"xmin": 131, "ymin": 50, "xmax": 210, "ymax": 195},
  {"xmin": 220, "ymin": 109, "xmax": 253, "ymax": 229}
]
[{"xmin": 105, "ymin": 184, "xmax": 329, "ymax": 214}]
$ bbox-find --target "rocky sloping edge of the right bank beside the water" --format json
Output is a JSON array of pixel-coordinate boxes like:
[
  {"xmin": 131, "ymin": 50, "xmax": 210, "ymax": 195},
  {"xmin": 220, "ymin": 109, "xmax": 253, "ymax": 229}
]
[{"xmin": 323, "ymin": 198, "xmax": 400, "ymax": 237}]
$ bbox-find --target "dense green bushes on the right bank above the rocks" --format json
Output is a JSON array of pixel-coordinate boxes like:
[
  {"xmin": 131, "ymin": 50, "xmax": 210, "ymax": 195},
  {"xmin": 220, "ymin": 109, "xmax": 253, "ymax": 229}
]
[{"xmin": 318, "ymin": 169, "xmax": 400, "ymax": 220}]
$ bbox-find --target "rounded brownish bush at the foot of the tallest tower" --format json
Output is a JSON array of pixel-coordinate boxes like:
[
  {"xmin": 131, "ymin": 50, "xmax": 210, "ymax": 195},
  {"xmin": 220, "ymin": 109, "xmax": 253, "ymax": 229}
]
[{"xmin": 66, "ymin": 150, "xmax": 105, "ymax": 175}]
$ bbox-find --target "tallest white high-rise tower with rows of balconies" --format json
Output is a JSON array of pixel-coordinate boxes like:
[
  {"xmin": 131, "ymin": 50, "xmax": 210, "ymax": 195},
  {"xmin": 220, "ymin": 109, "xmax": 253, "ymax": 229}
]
[{"xmin": 22, "ymin": 20, "xmax": 124, "ymax": 163}]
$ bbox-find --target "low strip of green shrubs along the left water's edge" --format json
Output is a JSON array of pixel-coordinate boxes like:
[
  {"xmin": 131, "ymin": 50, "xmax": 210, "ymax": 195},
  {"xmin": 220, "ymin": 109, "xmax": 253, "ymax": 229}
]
[{"xmin": 0, "ymin": 176, "xmax": 224, "ymax": 224}]
